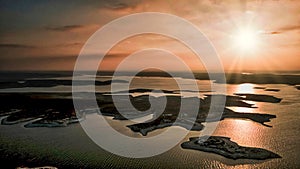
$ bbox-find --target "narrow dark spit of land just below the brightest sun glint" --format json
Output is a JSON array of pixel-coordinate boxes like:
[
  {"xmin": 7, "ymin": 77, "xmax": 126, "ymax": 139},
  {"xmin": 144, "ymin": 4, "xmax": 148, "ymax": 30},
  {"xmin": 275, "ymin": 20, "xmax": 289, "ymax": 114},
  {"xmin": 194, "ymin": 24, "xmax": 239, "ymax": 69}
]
[{"xmin": 235, "ymin": 93, "xmax": 282, "ymax": 103}]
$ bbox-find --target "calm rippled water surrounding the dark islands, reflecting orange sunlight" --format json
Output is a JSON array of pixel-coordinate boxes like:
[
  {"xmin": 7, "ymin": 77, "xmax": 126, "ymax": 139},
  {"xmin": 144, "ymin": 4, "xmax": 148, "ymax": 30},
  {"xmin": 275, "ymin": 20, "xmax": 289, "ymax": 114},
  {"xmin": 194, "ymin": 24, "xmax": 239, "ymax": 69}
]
[{"xmin": 0, "ymin": 77, "xmax": 300, "ymax": 168}]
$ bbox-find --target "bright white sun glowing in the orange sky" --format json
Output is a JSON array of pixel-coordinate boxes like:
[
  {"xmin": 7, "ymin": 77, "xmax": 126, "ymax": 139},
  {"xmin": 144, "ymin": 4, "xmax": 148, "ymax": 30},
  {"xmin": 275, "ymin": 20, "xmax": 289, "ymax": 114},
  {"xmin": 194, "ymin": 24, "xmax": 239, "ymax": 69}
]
[{"xmin": 233, "ymin": 29, "xmax": 259, "ymax": 52}]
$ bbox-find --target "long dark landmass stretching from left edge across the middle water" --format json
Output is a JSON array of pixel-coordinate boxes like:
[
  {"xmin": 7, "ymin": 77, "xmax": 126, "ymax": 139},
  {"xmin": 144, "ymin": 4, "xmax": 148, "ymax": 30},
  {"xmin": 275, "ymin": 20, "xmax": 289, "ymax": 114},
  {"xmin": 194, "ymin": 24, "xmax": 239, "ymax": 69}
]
[{"xmin": 0, "ymin": 89, "xmax": 276, "ymax": 132}]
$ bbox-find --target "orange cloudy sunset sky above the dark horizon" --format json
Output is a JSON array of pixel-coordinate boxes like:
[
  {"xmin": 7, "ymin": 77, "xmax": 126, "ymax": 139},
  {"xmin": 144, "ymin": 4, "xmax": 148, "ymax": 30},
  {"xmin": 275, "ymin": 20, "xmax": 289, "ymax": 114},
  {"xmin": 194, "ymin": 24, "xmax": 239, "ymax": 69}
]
[{"xmin": 0, "ymin": 0, "xmax": 300, "ymax": 71}]
